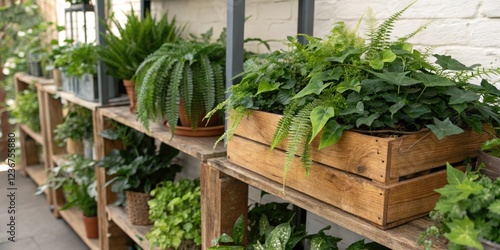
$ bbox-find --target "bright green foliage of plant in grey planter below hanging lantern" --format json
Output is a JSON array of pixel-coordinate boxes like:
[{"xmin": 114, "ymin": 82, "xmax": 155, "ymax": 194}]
[{"xmin": 54, "ymin": 43, "xmax": 98, "ymax": 77}]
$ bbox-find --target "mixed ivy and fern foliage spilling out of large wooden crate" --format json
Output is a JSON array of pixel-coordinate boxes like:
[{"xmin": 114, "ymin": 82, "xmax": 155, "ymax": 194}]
[{"xmin": 207, "ymin": 2, "xmax": 500, "ymax": 178}]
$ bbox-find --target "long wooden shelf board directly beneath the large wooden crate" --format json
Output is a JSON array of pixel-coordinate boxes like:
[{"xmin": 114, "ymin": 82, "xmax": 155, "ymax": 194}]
[{"xmin": 208, "ymin": 157, "xmax": 447, "ymax": 249}]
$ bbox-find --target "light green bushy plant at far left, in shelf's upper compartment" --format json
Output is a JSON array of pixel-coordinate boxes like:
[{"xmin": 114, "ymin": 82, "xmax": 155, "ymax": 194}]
[{"xmin": 8, "ymin": 87, "xmax": 40, "ymax": 132}]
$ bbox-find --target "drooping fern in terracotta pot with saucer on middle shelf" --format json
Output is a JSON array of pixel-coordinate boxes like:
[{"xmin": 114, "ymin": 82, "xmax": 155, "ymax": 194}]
[{"xmin": 136, "ymin": 37, "xmax": 225, "ymax": 136}]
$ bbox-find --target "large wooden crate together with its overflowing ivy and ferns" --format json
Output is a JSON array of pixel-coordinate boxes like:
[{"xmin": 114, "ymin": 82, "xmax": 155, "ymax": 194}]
[{"xmin": 209, "ymin": 3, "xmax": 500, "ymax": 228}]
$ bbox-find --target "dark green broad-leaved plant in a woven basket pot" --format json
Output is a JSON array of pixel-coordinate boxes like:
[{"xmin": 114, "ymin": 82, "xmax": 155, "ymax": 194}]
[{"xmin": 99, "ymin": 123, "xmax": 182, "ymax": 225}]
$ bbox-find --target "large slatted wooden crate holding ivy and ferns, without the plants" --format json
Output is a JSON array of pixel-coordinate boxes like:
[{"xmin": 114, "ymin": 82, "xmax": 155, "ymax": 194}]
[{"xmin": 227, "ymin": 111, "xmax": 489, "ymax": 229}]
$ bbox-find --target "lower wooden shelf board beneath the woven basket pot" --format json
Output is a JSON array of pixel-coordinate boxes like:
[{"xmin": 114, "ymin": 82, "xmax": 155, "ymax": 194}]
[{"xmin": 106, "ymin": 205, "xmax": 151, "ymax": 249}]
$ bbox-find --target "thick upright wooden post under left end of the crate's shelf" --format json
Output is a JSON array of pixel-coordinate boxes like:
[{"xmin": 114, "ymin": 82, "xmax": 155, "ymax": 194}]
[{"xmin": 200, "ymin": 163, "xmax": 248, "ymax": 249}]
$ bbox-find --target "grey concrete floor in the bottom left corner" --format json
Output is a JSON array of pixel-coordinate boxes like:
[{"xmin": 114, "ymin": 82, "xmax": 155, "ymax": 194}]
[{"xmin": 0, "ymin": 171, "xmax": 88, "ymax": 250}]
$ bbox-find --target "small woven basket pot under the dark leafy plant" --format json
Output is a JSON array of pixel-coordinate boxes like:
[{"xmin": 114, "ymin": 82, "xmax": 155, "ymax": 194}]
[{"xmin": 125, "ymin": 191, "xmax": 153, "ymax": 225}]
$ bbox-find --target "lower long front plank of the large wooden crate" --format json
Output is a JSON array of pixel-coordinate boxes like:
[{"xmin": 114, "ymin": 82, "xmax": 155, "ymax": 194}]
[{"xmin": 228, "ymin": 135, "xmax": 387, "ymax": 226}]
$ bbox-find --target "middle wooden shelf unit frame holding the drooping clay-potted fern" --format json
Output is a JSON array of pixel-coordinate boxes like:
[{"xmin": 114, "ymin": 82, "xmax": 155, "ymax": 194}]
[{"xmin": 94, "ymin": 106, "xmax": 227, "ymax": 250}]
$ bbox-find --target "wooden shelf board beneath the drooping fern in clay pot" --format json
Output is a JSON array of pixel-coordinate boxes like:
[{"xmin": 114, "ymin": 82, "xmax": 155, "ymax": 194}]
[{"xmin": 100, "ymin": 106, "xmax": 226, "ymax": 161}]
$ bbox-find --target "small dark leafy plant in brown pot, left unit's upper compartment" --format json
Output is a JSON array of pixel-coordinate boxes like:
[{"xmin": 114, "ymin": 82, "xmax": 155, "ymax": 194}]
[{"xmin": 54, "ymin": 105, "xmax": 94, "ymax": 159}]
